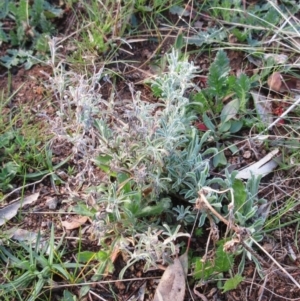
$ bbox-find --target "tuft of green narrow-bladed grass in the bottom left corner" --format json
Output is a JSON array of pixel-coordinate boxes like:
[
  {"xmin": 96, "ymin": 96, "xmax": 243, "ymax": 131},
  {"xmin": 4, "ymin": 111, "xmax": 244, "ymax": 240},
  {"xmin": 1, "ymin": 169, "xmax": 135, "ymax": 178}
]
[{"xmin": 0, "ymin": 226, "xmax": 82, "ymax": 301}]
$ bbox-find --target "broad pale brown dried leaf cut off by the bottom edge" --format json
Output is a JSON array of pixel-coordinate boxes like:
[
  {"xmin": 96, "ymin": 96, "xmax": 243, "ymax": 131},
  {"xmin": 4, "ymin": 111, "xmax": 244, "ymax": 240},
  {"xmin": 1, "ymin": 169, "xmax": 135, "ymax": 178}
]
[{"xmin": 153, "ymin": 258, "xmax": 186, "ymax": 301}]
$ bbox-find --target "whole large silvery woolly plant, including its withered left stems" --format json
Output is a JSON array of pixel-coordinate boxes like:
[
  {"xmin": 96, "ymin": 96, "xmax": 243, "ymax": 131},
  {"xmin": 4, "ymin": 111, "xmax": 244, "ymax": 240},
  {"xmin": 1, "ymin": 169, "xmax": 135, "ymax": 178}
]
[{"xmin": 42, "ymin": 40, "xmax": 270, "ymax": 276}]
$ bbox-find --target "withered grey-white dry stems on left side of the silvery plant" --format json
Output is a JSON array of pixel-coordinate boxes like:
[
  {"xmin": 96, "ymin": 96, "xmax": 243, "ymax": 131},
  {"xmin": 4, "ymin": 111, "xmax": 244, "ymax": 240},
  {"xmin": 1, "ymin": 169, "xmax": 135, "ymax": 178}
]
[{"xmin": 39, "ymin": 38, "xmax": 104, "ymax": 183}]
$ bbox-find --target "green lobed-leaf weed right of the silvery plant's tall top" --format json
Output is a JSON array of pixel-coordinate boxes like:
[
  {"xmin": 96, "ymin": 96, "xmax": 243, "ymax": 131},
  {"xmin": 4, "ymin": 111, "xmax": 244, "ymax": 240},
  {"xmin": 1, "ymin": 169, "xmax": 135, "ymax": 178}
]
[{"xmin": 193, "ymin": 50, "xmax": 251, "ymax": 166}]
